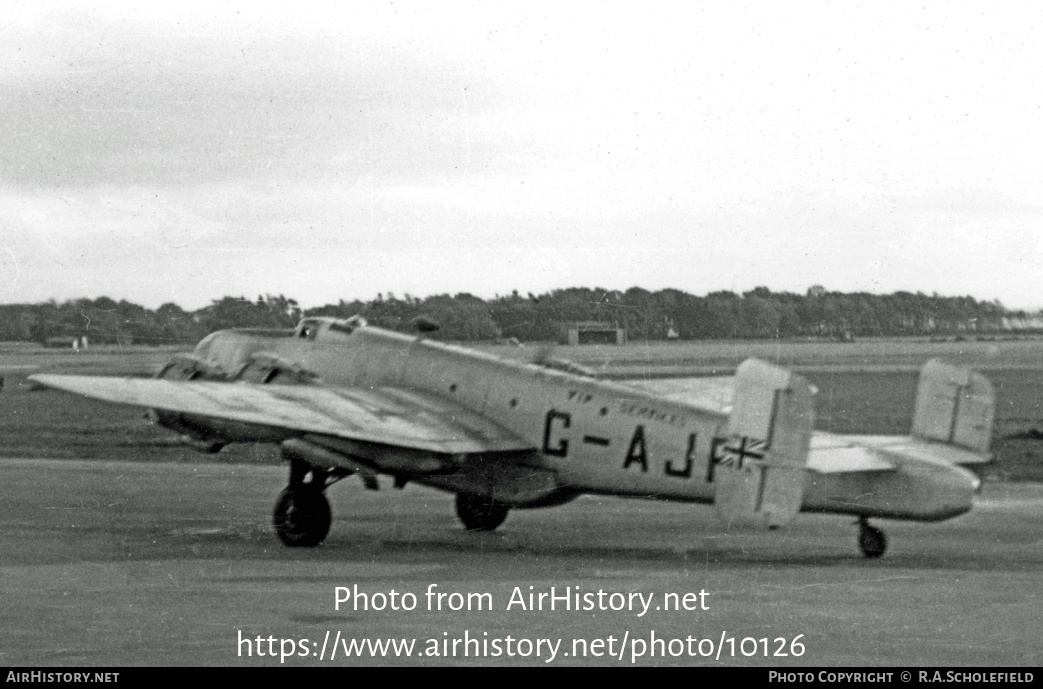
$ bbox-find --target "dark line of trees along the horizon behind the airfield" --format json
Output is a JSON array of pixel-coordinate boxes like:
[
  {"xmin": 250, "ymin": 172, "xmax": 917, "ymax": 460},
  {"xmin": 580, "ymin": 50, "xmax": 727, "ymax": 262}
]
[{"xmin": 0, "ymin": 287, "xmax": 1028, "ymax": 345}]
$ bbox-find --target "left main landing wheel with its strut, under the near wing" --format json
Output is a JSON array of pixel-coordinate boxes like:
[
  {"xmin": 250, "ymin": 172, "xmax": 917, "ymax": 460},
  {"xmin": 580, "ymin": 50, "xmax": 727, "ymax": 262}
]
[{"xmin": 272, "ymin": 460, "xmax": 332, "ymax": 548}]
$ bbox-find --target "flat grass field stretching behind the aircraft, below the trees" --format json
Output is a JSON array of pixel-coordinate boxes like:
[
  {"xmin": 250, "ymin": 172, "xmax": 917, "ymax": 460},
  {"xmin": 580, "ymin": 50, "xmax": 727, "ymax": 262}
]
[{"xmin": 0, "ymin": 340, "xmax": 1043, "ymax": 481}]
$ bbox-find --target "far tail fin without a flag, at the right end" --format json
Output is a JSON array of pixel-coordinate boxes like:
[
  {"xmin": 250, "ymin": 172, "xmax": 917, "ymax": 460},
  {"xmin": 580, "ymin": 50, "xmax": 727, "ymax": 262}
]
[{"xmin": 911, "ymin": 359, "xmax": 996, "ymax": 453}]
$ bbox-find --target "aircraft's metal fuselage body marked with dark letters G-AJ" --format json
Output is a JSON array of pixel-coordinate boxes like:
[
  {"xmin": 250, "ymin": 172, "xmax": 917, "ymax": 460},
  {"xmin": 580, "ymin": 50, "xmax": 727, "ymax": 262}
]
[{"xmin": 187, "ymin": 319, "xmax": 974, "ymax": 520}]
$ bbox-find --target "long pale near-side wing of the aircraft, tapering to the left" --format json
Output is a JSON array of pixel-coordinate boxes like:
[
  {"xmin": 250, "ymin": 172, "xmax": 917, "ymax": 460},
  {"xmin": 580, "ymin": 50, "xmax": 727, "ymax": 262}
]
[{"xmin": 29, "ymin": 375, "xmax": 535, "ymax": 454}]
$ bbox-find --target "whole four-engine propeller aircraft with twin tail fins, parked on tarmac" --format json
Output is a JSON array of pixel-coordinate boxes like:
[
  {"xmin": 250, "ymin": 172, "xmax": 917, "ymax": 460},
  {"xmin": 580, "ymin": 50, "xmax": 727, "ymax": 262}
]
[{"xmin": 30, "ymin": 317, "xmax": 994, "ymax": 558}]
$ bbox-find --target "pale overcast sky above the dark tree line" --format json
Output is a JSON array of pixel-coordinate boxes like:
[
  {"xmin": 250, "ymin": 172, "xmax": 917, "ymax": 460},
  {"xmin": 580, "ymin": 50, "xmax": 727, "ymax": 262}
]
[{"xmin": 0, "ymin": 0, "xmax": 1043, "ymax": 309}]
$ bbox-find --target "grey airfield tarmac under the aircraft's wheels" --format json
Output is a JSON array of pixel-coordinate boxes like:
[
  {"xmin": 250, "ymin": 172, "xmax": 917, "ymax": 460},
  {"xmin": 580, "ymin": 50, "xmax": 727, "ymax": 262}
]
[{"xmin": 0, "ymin": 459, "xmax": 1043, "ymax": 667}]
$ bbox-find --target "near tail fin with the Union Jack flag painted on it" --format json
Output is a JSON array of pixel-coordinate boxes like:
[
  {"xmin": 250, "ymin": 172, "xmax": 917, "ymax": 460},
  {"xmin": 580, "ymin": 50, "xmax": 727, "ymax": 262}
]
[{"xmin": 714, "ymin": 359, "xmax": 814, "ymax": 527}]
